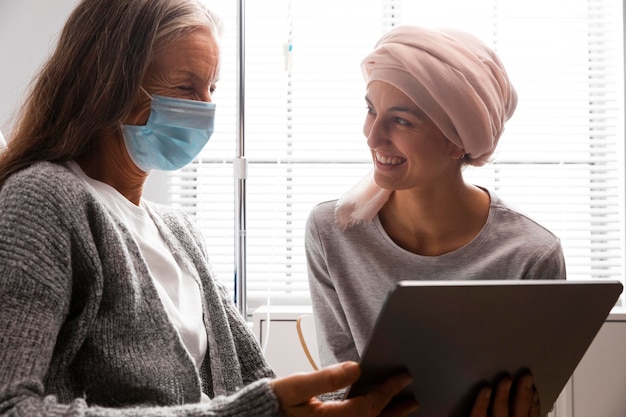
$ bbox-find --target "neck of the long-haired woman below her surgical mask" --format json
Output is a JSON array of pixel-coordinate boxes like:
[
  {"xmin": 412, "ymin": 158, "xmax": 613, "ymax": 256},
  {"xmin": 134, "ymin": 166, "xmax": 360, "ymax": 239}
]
[{"xmin": 76, "ymin": 133, "xmax": 148, "ymax": 205}]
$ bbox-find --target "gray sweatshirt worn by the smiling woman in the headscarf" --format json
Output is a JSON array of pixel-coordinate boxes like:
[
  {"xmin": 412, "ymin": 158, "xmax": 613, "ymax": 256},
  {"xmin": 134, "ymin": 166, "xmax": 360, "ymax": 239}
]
[{"xmin": 305, "ymin": 193, "xmax": 565, "ymax": 366}]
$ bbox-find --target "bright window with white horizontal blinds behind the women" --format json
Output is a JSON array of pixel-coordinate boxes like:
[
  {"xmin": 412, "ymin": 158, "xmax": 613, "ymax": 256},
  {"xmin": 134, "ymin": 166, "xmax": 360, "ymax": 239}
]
[{"xmin": 168, "ymin": 0, "xmax": 625, "ymax": 312}]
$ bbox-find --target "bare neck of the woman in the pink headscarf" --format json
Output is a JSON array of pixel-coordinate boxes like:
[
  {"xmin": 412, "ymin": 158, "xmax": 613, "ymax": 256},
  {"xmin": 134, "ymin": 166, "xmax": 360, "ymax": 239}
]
[{"xmin": 378, "ymin": 182, "xmax": 490, "ymax": 256}]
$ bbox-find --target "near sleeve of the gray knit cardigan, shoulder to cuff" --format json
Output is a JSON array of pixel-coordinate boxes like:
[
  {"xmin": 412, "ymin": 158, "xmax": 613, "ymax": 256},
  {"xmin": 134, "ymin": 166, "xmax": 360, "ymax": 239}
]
[{"xmin": 0, "ymin": 164, "xmax": 280, "ymax": 417}]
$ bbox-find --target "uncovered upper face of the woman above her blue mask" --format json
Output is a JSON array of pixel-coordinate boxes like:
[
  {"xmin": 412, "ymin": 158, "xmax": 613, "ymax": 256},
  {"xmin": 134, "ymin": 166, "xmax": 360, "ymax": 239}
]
[{"xmin": 125, "ymin": 24, "xmax": 219, "ymax": 125}]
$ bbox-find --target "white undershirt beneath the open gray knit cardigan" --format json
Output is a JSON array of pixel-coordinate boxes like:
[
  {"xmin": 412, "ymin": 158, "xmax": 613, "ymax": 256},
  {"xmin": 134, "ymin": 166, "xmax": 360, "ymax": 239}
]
[{"xmin": 68, "ymin": 161, "xmax": 207, "ymax": 369}]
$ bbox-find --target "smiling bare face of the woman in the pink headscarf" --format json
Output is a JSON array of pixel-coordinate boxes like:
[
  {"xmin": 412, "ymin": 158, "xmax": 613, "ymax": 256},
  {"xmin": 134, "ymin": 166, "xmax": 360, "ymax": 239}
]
[{"xmin": 363, "ymin": 81, "xmax": 463, "ymax": 190}]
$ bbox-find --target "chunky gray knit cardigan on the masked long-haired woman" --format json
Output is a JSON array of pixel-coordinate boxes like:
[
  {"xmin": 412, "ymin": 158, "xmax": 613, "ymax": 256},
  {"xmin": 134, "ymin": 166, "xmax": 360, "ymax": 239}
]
[{"xmin": 0, "ymin": 162, "xmax": 280, "ymax": 417}]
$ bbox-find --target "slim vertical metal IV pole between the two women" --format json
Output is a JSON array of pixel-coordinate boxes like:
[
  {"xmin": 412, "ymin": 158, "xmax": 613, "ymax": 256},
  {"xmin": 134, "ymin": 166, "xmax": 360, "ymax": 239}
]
[{"xmin": 233, "ymin": 0, "xmax": 248, "ymax": 319}]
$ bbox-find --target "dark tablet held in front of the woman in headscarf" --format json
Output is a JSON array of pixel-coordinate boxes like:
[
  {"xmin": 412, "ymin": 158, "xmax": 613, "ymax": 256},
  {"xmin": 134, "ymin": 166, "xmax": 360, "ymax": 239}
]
[{"xmin": 346, "ymin": 280, "xmax": 622, "ymax": 417}]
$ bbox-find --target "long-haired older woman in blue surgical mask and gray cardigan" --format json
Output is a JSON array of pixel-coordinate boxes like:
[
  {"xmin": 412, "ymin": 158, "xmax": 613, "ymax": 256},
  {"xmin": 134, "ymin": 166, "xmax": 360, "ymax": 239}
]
[{"xmin": 0, "ymin": 0, "xmax": 424, "ymax": 416}]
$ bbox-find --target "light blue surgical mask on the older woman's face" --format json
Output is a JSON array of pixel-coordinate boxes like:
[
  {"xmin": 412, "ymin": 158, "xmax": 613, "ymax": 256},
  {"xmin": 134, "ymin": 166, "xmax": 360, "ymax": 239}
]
[{"xmin": 122, "ymin": 88, "xmax": 215, "ymax": 172}]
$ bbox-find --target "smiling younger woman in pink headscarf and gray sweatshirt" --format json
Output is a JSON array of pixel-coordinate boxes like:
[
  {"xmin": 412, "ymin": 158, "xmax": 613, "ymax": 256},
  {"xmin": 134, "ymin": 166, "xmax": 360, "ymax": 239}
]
[{"xmin": 306, "ymin": 26, "xmax": 565, "ymax": 412}]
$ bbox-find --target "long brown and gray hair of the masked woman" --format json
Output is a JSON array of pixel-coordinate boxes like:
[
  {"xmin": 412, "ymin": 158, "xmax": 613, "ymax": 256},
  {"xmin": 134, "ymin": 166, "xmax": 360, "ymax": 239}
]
[{"xmin": 0, "ymin": 0, "xmax": 222, "ymax": 187}]
